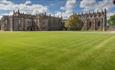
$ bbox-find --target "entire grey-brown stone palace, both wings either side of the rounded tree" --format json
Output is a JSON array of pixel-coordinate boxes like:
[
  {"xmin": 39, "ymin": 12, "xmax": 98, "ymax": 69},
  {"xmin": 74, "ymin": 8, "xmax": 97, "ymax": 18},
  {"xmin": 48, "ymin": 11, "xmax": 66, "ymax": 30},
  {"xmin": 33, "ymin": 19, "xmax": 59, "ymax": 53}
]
[{"xmin": 0, "ymin": 10, "xmax": 107, "ymax": 31}]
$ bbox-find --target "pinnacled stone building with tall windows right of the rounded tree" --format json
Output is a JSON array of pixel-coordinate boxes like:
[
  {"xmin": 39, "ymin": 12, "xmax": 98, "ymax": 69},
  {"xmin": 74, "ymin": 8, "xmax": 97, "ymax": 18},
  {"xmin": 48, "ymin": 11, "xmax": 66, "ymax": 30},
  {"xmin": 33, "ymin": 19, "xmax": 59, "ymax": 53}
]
[{"xmin": 74, "ymin": 9, "xmax": 107, "ymax": 31}]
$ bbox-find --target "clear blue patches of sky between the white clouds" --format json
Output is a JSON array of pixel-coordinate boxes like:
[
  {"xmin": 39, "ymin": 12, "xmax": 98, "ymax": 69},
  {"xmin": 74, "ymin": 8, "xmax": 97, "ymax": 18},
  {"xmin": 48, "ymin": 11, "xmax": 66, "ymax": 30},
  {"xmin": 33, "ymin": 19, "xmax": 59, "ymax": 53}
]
[{"xmin": 4, "ymin": 0, "xmax": 81, "ymax": 13}]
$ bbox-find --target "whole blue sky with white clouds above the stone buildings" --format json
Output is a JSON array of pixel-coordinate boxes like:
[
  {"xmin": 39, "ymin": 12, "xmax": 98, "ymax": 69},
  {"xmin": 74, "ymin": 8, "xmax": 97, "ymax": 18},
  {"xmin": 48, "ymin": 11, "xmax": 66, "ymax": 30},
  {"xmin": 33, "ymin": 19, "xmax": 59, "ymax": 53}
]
[{"xmin": 0, "ymin": 0, "xmax": 115, "ymax": 18}]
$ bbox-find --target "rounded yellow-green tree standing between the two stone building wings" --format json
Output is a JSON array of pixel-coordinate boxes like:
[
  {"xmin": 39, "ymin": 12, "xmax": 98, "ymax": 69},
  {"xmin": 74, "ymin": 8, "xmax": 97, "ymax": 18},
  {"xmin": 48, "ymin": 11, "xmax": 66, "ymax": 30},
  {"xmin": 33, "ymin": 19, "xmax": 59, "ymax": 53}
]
[{"xmin": 65, "ymin": 15, "xmax": 81, "ymax": 30}]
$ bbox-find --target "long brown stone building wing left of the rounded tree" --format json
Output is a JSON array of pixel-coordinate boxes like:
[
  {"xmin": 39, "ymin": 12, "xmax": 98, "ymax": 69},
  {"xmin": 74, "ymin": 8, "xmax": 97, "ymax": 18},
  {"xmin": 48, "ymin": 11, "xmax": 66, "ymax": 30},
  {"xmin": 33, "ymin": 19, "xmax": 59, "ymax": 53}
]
[{"xmin": 0, "ymin": 11, "xmax": 64, "ymax": 31}]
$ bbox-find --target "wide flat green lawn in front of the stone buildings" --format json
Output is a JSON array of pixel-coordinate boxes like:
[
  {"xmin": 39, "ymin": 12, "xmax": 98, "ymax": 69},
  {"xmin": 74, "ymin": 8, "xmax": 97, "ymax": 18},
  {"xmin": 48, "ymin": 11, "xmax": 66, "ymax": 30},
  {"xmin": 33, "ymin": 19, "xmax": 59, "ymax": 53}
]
[{"xmin": 0, "ymin": 32, "xmax": 115, "ymax": 70}]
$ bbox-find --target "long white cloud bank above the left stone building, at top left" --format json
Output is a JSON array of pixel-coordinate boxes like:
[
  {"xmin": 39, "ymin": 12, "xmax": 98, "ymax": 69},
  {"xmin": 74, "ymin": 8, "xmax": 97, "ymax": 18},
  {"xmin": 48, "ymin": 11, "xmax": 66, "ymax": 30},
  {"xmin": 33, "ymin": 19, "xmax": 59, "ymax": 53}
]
[{"xmin": 0, "ymin": 0, "xmax": 48, "ymax": 14}]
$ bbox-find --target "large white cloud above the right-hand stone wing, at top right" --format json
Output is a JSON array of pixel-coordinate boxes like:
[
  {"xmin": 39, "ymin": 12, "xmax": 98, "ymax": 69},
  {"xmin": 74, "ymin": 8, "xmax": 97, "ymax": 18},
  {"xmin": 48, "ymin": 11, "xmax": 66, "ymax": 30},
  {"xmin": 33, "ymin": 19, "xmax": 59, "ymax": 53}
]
[{"xmin": 80, "ymin": 0, "xmax": 115, "ymax": 18}]
